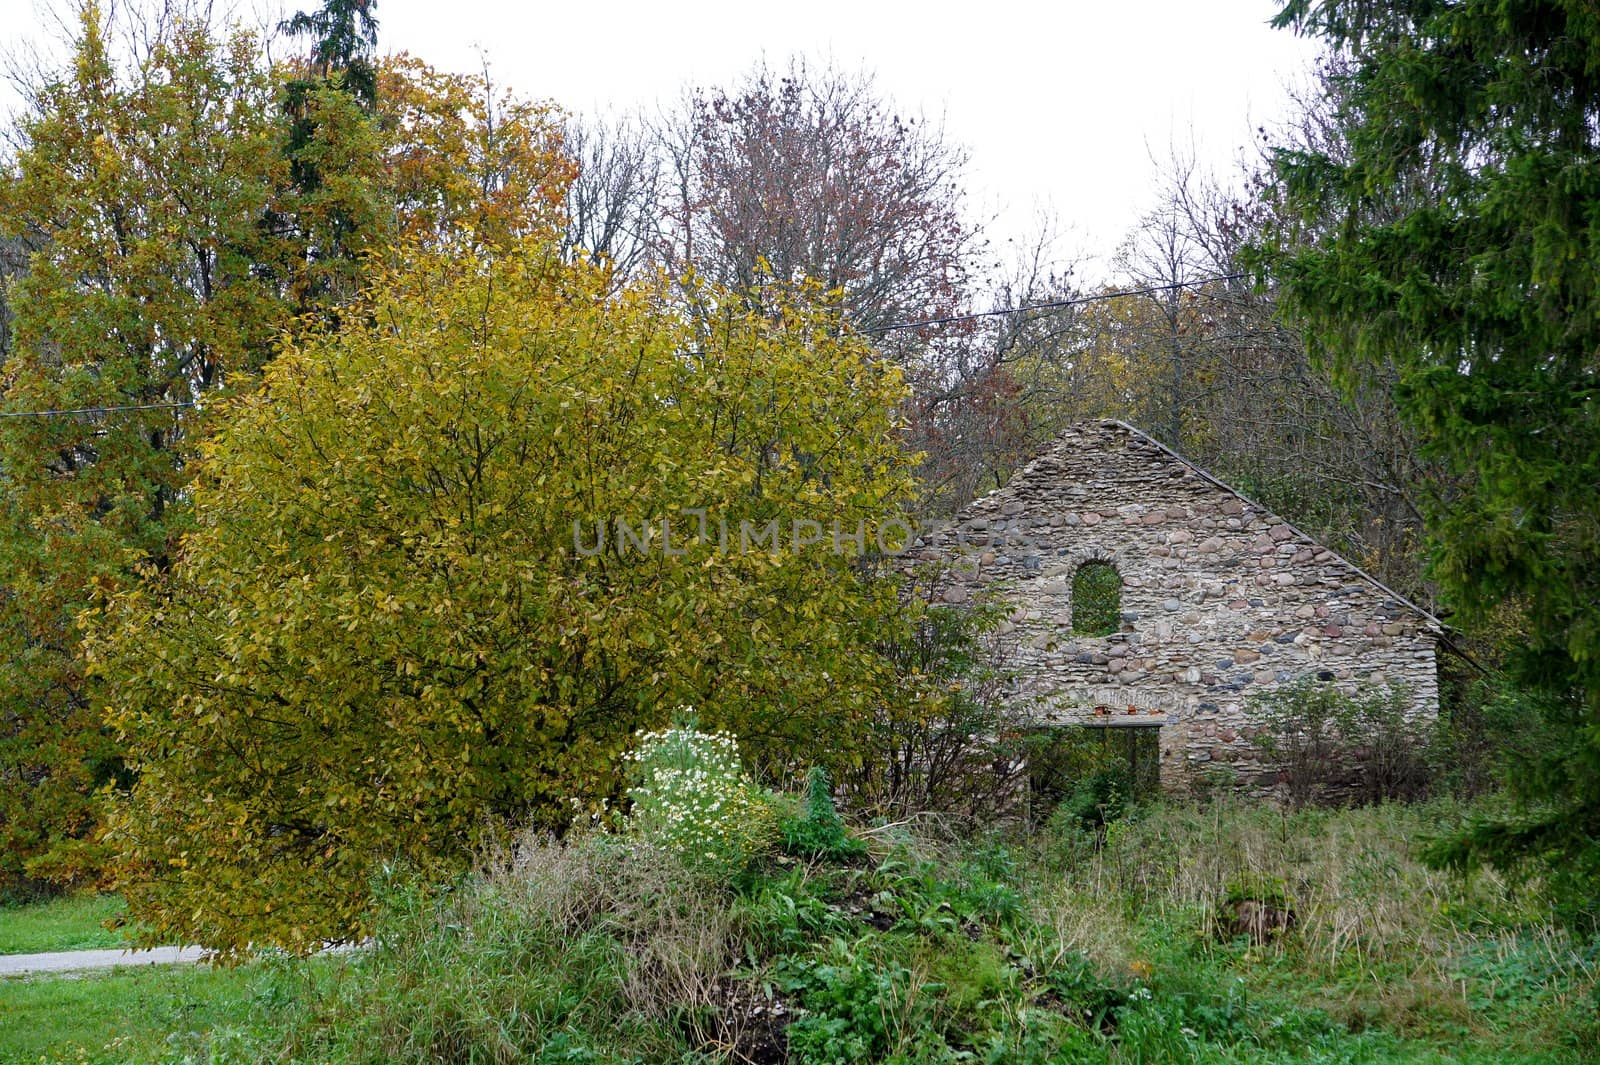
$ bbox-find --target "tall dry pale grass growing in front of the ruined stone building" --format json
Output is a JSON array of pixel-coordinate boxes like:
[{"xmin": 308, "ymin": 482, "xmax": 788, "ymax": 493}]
[{"xmin": 1032, "ymin": 798, "xmax": 1595, "ymax": 1028}]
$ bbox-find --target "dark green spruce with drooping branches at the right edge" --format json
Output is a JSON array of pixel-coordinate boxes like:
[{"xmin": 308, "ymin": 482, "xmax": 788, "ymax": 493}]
[{"xmin": 1261, "ymin": 0, "xmax": 1600, "ymax": 918}]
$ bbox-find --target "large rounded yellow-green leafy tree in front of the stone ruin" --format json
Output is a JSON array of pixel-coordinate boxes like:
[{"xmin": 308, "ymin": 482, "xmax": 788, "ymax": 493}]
[{"xmin": 90, "ymin": 238, "xmax": 912, "ymax": 953}]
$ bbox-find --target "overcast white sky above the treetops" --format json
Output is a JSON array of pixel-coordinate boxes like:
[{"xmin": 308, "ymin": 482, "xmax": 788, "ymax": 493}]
[{"xmin": 0, "ymin": 0, "xmax": 1315, "ymax": 277}]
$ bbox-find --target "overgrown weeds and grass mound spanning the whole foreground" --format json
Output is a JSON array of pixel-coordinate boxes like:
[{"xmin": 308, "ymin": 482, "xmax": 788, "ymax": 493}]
[{"xmin": 0, "ymin": 782, "xmax": 1600, "ymax": 1065}]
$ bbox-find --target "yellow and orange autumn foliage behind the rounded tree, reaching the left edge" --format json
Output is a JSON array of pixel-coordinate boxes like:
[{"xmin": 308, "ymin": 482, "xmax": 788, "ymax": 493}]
[{"xmin": 0, "ymin": 3, "xmax": 573, "ymax": 892}]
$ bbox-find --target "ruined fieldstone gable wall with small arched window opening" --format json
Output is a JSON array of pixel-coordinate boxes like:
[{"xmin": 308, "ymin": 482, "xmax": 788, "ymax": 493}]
[{"xmin": 917, "ymin": 422, "xmax": 1443, "ymax": 790}]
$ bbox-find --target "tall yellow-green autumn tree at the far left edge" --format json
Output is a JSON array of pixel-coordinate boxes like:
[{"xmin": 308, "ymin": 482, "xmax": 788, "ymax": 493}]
[{"xmin": 0, "ymin": 11, "xmax": 293, "ymax": 889}]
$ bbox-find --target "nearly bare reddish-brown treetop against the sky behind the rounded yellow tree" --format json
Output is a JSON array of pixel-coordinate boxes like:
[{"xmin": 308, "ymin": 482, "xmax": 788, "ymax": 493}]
[{"xmin": 659, "ymin": 61, "xmax": 976, "ymax": 347}]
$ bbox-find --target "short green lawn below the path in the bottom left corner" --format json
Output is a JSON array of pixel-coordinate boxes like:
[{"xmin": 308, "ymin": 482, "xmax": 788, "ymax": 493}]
[{"xmin": 0, "ymin": 966, "xmax": 251, "ymax": 1065}]
